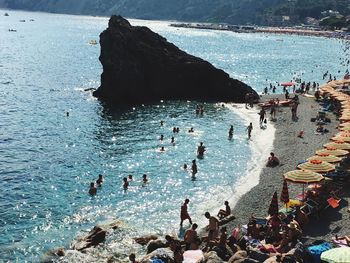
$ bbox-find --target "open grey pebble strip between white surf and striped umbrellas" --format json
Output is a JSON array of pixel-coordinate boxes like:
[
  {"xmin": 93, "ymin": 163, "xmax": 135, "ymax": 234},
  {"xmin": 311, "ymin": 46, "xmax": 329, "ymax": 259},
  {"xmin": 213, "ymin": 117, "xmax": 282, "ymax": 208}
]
[{"xmin": 231, "ymin": 95, "xmax": 338, "ymax": 229}]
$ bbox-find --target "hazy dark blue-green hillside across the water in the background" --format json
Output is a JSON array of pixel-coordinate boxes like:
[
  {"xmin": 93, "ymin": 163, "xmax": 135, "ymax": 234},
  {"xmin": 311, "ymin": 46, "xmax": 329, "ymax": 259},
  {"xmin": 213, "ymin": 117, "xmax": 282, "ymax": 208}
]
[{"xmin": 0, "ymin": 0, "xmax": 350, "ymax": 25}]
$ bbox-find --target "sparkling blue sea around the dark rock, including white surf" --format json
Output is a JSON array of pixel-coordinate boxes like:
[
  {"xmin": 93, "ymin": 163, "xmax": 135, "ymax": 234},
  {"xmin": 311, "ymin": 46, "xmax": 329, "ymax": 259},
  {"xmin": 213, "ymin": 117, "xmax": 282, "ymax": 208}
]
[{"xmin": 0, "ymin": 10, "xmax": 347, "ymax": 262}]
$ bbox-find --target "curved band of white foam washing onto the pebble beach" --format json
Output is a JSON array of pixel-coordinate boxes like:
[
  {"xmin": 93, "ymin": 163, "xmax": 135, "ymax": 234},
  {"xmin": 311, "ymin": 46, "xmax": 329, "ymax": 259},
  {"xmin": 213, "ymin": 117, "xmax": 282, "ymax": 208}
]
[{"xmin": 225, "ymin": 104, "xmax": 276, "ymax": 210}]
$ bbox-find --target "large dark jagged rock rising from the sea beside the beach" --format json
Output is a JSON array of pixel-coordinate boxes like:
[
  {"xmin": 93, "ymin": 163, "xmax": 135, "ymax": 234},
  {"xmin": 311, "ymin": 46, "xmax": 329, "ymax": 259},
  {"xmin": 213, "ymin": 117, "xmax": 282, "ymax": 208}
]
[{"xmin": 94, "ymin": 16, "xmax": 256, "ymax": 104}]
